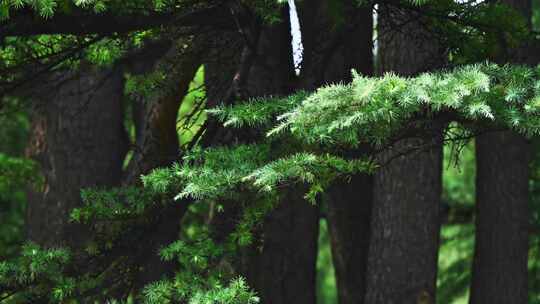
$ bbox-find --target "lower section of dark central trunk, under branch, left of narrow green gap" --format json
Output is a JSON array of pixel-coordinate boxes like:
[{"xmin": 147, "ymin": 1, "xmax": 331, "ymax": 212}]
[{"xmin": 248, "ymin": 189, "xmax": 319, "ymax": 304}]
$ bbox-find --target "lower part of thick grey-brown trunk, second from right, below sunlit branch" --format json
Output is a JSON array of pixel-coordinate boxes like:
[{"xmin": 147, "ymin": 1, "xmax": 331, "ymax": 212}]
[{"xmin": 366, "ymin": 132, "xmax": 442, "ymax": 304}]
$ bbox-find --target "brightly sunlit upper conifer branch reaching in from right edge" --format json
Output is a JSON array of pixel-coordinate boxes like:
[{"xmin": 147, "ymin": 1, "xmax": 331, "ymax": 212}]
[{"xmin": 268, "ymin": 64, "xmax": 540, "ymax": 147}]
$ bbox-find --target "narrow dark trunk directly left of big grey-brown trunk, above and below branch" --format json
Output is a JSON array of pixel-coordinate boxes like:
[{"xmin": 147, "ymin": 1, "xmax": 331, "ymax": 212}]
[{"xmin": 316, "ymin": 3, "xmax": 373, "ymax": 304}]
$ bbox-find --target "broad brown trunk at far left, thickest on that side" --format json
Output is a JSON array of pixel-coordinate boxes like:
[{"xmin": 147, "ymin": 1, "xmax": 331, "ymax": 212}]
[{"xmin": 26, "ymin": 67, "xmax": 127, "ymax": 246}]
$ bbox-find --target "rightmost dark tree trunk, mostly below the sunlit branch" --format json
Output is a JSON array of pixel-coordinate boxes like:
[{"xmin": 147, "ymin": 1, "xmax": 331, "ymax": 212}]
[{"xmin": 470, "ymin": 0, "xmax": 534, "ymax": 304}]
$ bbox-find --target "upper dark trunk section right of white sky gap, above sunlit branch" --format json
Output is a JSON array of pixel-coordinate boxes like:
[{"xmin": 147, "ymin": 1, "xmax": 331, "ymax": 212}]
[{"xmin": 298, "ymin": 0, "xmax": 373, "ymax": 90}]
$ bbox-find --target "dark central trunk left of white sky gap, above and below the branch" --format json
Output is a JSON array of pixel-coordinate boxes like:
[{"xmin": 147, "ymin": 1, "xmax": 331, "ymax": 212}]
[{"xmin": 242, "ymin": 14, "xmax": 319, "ymax": 304}]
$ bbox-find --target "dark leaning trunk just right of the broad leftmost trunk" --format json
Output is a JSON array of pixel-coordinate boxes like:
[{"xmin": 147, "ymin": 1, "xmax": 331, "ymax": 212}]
[{"xmin": 123, "ymin": 41, "xmax": 204, "ymax": 185}]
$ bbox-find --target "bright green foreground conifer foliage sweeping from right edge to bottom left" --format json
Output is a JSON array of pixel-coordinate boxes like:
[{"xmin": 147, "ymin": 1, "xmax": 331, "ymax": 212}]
[{"xmin": 6, "ymin": 64, "xmax": 540, "ymax": 303}]
